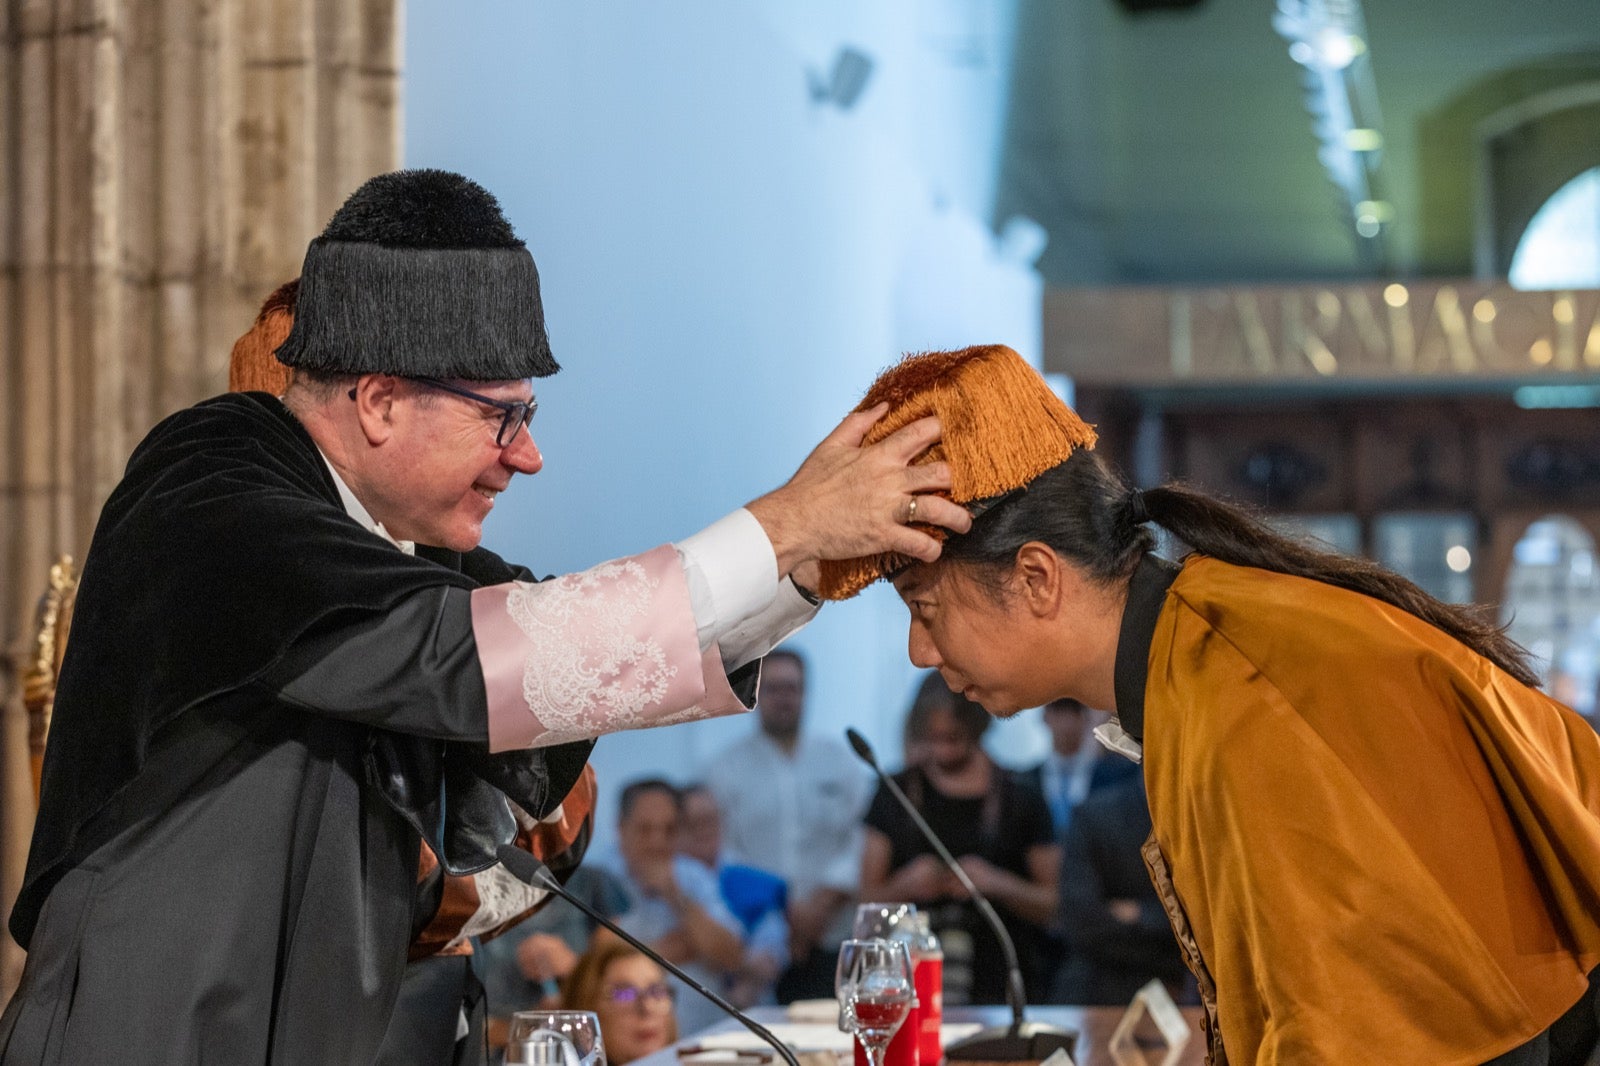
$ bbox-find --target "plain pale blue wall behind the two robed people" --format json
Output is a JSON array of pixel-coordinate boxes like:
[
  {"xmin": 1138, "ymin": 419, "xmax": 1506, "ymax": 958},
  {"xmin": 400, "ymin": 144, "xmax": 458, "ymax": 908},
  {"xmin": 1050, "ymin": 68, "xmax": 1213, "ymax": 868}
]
[{"xmin": 405, "ymin": 0, "xmax": 1042, "ymax": 829}]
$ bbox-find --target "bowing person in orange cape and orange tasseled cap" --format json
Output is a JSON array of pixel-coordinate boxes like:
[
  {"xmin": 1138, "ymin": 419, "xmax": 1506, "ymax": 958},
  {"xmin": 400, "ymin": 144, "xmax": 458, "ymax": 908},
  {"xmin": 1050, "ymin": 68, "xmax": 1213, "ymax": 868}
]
[{"xmin": 822, "ymin": 347, "xmax": 1600, "ymax": 1066}]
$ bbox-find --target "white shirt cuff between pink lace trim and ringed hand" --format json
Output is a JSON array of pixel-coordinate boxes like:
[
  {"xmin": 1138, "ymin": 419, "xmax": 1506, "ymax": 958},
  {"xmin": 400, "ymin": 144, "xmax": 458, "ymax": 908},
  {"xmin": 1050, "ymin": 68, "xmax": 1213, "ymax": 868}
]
[{"xmin": 674, "ymin": 507, "xmax": 778, "ymax": 651}]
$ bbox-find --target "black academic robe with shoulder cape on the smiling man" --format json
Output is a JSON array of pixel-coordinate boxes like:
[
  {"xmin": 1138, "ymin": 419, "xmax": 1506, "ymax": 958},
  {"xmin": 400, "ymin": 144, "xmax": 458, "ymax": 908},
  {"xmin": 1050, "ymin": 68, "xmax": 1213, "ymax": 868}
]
[{"xmin": 0, "ymin": 394, "xmax": 590, "ymax": 1066}]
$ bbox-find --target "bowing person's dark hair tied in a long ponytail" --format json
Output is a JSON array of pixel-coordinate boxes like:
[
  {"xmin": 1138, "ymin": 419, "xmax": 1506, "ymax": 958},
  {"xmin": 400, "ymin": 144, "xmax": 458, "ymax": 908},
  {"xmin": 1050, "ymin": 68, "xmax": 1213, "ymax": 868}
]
[{"xmin": 944, "ymin": 450, "xmax": 1539, "ymax": 687}]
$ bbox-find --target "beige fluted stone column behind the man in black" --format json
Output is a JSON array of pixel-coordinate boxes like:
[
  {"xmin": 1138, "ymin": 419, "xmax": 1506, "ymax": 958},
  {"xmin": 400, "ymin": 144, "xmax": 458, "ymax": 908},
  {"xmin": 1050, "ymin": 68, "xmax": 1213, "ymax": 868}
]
[{"xmin": 0, "ymin": 0, "xmax": 400, "ymax": 1002}]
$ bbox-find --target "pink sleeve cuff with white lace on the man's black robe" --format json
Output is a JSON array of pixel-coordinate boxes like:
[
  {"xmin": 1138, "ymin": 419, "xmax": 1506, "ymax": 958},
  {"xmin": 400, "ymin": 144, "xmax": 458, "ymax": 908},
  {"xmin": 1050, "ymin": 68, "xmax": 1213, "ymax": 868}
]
[{"xmin": 472, "ymin": 544, "xmax": 746, "ymax": 751}]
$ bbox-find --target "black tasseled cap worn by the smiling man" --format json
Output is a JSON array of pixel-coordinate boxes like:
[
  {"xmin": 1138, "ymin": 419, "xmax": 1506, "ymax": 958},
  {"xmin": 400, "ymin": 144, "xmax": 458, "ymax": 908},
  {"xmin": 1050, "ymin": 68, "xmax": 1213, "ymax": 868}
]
[{"xmin": 277, "ymin": 170, "xmax": 560, "ymax": 381}]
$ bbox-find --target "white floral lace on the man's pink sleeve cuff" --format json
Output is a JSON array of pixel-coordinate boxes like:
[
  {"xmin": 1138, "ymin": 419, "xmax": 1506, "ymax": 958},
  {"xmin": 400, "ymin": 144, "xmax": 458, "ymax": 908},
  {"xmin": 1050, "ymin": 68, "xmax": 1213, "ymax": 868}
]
[{"xmin": 506, "ymin": 560, "xmax": 677, "ymax": 743}]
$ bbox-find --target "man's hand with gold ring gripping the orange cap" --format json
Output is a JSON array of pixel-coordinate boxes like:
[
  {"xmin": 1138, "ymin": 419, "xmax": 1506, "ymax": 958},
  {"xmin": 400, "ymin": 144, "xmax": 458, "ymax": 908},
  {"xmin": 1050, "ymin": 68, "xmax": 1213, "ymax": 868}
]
[{"xmin": 749, "ymin": 403, "xmax": 973, "ymax": 575}]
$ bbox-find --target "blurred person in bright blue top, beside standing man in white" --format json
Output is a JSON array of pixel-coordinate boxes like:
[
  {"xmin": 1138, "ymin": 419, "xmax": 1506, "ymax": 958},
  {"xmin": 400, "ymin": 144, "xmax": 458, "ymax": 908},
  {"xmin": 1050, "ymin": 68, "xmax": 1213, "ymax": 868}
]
[{"xmin": 678, "ymin": 784, "xmax": 789, "ymax": 1007}]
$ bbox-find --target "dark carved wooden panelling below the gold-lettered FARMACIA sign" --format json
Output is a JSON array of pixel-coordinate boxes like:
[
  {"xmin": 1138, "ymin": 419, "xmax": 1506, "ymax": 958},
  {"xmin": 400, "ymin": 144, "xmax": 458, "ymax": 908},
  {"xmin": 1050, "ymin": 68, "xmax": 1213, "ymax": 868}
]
[{"xmin": 1077, "ymin": 390, "xmax": 1600, "ymax": 607}]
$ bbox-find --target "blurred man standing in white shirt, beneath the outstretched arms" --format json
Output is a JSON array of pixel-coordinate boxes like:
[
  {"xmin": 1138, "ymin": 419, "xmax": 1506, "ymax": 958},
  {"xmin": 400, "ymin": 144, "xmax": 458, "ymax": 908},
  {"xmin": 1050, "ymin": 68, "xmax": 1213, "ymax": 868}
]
[{"xmin": 706, "ymin": 648, "xmax": 869, "ymax": 1002}]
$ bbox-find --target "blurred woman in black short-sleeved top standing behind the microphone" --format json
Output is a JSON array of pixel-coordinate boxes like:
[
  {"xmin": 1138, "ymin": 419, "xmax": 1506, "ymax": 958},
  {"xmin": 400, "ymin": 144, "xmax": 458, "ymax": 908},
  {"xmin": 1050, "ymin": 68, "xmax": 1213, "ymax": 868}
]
[{"xmin": 861, "ymin": 674, "xmax": 1061, "ymax": 1005}]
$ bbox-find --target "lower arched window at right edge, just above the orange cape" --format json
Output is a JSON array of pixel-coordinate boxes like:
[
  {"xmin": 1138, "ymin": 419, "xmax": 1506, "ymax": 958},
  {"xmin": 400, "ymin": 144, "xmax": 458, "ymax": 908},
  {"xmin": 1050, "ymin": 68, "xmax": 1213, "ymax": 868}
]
[{"xmin": 1502, "ymin": 515, "xmax": 1600, "ymax": 715}]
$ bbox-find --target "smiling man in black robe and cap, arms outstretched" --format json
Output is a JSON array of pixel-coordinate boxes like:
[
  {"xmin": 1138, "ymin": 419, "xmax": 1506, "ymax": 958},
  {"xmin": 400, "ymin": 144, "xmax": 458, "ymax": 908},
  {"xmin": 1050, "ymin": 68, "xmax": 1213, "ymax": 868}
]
[{"xmin": 0, "ymin": 171, "xmax": 965, "ymax": 1066}]
